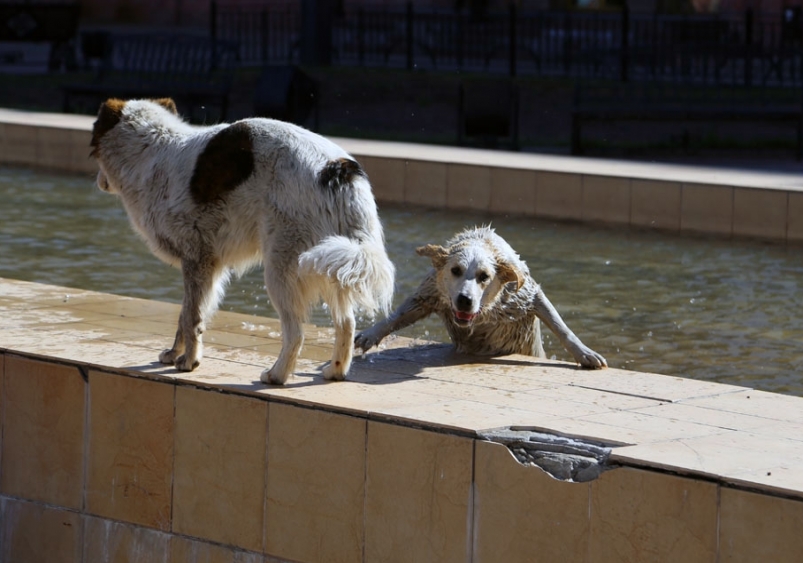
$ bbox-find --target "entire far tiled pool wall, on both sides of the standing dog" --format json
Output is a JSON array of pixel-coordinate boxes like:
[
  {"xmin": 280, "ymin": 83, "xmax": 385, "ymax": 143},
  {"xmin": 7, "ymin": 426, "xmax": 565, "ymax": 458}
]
[{"xmin": 0, "ymin": 115, "xmax": 803, "ymax": 243}]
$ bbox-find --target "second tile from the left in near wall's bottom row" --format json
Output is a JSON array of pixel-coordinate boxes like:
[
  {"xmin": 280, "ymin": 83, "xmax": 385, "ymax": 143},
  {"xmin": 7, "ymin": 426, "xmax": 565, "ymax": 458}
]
[{"xmin": 83, "ymin": 516, "xmax": 171, "ymax": 563}]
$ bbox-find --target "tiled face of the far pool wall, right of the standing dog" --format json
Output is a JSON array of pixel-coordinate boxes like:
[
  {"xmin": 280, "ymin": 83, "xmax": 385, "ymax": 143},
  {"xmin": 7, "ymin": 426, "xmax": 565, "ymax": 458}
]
[{"xmin": 356, "ymin": 154, "xmax": 803, "ymax": 242}]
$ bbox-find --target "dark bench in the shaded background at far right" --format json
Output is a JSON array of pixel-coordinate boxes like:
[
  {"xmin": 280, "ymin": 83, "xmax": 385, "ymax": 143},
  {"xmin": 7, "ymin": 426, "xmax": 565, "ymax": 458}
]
[{"xmin": 571, "ymin": 82, "xmax": 803, "ymax": 160}]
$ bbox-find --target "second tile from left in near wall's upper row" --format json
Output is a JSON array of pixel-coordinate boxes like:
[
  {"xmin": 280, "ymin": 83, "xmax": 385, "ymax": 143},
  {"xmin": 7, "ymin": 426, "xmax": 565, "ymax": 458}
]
[{"xmin": 86, "ymin": 371, "xmax": 175, "ymax": 531}]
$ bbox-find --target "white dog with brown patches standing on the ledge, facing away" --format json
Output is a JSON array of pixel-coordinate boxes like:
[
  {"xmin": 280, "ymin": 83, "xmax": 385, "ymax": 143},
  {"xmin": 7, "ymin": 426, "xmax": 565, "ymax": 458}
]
[{"xmin": 91, "ymin": 99, "xmax": 394, "ymax": 384}]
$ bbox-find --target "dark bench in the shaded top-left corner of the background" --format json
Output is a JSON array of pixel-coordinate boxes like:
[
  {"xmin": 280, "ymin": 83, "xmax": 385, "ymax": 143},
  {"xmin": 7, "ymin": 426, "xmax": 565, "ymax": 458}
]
[{"xmin": 0, "ymin": 2, "xmax": 80, "ymax": 71}]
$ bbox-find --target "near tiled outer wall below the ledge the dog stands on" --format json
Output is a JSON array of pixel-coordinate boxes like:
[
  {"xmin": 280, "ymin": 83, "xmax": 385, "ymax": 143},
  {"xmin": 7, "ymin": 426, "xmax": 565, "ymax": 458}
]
[{"xmin": 0, "ymin": 352, "xmax": 803, "ymax": 563}]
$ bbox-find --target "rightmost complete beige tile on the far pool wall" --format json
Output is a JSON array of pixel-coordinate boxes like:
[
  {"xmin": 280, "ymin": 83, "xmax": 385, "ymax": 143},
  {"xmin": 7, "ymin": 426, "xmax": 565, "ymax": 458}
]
[{"xmin": 733, "ymin": 188, "xmax": 788, "ymax": 240}]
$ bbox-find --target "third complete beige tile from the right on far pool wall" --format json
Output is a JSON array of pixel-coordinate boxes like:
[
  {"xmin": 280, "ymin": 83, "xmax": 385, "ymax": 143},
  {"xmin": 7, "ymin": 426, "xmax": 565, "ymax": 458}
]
[{"xmin": 630, "ymin": 180, "xmax": 681, "ymax": 232}]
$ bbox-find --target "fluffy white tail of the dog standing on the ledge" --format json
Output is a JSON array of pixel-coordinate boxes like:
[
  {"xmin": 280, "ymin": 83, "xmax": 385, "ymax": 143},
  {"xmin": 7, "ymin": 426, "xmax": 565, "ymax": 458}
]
[{"xmin": 298, "ymin": 235, "xmax": 396, "ymax": 315}]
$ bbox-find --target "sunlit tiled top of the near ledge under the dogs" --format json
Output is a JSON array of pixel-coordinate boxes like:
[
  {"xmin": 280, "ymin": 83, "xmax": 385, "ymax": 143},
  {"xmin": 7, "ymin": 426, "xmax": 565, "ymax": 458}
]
[{"xmin": 0, "ymin": 279, "xmax": 803, "ymax": 498}]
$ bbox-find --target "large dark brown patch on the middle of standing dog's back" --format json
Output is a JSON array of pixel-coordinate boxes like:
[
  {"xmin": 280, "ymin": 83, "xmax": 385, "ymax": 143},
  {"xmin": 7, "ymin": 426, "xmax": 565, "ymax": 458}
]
[{"xmin": 190, "ymin": 122, "xmax": 254, "ymax": 205}]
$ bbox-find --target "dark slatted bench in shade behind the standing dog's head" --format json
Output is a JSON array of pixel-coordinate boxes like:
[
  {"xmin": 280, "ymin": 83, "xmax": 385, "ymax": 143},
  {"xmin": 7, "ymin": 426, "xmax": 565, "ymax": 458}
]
[{"xmin": 63, "ymin": 34, "xmax": 237, "ymax": 122}]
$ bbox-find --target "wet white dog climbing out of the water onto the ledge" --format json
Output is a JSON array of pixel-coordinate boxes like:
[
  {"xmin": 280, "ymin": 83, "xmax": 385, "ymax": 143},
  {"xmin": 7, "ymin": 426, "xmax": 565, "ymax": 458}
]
[{"xmin": 354, "ymin": 227, "xmax": 608, "ymax": 368}]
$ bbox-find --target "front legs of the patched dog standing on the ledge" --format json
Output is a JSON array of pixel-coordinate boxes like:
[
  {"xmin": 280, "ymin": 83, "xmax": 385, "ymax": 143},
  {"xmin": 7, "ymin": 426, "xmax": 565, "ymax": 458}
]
[{"xmin": 159, "ymin": 256, "xmax": 223, "ymax": 371}]
